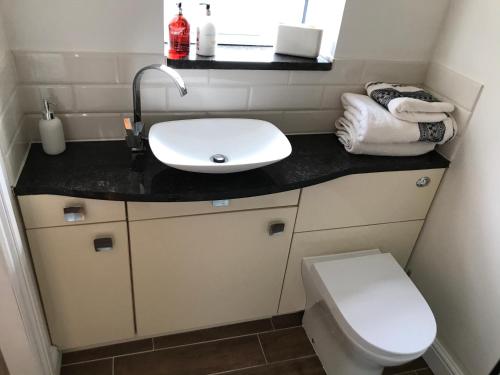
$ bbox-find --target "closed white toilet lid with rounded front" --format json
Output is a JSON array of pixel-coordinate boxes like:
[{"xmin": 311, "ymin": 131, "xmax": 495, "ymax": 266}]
[{"xmin": 313, "ymin": 254, "xmax": 436, "ymax": 356}]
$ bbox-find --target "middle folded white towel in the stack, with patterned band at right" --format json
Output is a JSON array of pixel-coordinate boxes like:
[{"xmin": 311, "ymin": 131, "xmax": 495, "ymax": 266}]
[{"xmin": 341, "ymin": 93, "xmax": 456, "ymax": 144}]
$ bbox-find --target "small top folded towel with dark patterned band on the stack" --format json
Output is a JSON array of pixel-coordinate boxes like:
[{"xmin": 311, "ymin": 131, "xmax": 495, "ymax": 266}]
[{"xmin": 365, "ymin": 82, "xmax": 454, "ymax": 122}]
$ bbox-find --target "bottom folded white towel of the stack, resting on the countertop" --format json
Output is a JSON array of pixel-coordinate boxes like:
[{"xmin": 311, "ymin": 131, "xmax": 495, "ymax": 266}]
[{"xmin": 335, "ymin": 118, "xmax": 435, "ymax": 156}]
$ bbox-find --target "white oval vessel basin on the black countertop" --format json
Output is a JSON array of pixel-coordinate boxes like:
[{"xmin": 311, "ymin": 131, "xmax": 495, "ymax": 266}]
[{"xmin": 149, "ymin": 118, "xmax": 292, "ymax": 173}]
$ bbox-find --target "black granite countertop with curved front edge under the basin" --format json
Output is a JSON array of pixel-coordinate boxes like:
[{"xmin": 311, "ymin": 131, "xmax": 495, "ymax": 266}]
[{"xmin": 15, "ymin": 134, "xmax": 449, "ymax": 202}]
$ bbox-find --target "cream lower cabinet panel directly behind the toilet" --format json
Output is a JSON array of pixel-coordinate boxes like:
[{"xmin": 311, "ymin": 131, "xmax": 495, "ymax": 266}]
[{"xmin": 279, "ymin": 220, "xmax": 424, "ymax": 314}]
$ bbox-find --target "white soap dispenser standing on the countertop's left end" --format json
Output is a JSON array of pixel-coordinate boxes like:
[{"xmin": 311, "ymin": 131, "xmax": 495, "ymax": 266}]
[{"xmin": 38, "ymin": 99, "xmax": 66, "ymax": 155}]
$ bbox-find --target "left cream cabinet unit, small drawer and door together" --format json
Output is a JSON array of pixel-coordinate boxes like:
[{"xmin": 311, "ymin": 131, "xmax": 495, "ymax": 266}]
[{"xmin": 18, "ymin": 195, "xmax": 135, "ymax": 349}]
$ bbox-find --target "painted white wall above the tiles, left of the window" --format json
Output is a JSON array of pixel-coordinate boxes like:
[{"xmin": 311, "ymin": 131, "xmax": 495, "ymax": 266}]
[{"xmin": 1, "ymin": 0, "xmax": 163, "ymax": 53}]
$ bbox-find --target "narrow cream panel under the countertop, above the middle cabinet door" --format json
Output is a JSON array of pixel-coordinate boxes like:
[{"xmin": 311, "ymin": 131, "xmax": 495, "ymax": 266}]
[{"xmin": 127, "ymin": 190, "xmax": 300, "ymax": 220}]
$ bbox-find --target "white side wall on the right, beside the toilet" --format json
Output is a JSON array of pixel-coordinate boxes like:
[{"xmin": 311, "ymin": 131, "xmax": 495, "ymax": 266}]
[{"xmin": 410, "ymin": 0, "xmax": 500, "ymax": 375}]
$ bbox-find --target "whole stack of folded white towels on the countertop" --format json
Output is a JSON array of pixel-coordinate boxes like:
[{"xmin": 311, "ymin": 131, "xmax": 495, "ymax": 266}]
[{"xmin": 335, "ymin": 82, "xmax": 456, "ymax": 156}]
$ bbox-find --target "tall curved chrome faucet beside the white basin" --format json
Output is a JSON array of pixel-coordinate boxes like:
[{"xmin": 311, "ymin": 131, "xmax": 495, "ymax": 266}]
[{"xmin": 124, "ymin": 64, "xmax": 187, "ymax": 152}]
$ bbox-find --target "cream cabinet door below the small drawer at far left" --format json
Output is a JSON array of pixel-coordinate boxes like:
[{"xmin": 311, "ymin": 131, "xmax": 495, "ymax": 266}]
[{"xmin": 27, "ymin": 222, "xmax": 134, "ymax": 349}]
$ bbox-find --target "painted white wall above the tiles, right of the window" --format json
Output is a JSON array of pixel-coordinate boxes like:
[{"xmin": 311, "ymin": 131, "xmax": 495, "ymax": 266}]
[{"xmin": 335, "ymin": 0, "xmax": 449, "ymax": 61}]
